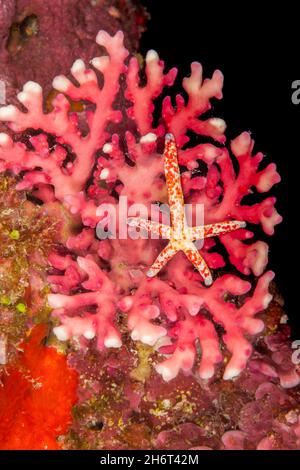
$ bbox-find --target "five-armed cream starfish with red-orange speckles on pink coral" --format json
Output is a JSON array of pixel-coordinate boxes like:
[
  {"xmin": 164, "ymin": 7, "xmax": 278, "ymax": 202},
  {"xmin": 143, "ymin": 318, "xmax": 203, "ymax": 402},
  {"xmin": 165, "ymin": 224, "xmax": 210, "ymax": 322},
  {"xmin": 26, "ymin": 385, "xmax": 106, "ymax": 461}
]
[{"xmin": 127, "ymin": 134, "xmax": 246, "ymax": 286}]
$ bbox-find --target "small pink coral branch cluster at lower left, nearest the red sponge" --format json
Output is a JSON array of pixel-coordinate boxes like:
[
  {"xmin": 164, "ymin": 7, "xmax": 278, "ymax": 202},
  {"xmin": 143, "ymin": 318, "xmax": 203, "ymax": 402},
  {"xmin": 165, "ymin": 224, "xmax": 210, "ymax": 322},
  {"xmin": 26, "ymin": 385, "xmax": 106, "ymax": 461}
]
[{"xmin": 48, "ymin": 257, "xmax": 121, "ymax": 349}]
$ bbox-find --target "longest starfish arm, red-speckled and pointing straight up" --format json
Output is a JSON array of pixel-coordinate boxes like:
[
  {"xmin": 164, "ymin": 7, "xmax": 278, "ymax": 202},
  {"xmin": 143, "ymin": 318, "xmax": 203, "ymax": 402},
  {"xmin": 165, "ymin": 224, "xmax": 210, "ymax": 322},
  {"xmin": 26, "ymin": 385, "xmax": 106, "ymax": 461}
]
[{"xmin": 164, "ymin": 134, "xmax": 185, "ymax": 234}]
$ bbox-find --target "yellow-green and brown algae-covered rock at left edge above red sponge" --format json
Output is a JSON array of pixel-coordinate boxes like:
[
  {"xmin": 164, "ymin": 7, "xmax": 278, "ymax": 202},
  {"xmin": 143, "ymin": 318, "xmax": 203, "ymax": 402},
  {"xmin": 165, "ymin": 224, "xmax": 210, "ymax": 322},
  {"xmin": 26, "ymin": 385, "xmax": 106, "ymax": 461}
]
[{"xmin": 0, "ymin": 175, "xmax": 58, "ymax": 360}]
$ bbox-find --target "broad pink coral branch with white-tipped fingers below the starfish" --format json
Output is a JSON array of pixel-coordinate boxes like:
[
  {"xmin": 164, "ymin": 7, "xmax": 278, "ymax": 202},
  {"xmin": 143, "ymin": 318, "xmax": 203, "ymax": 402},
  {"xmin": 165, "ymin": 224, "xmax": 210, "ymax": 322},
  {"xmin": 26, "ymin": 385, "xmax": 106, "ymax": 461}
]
[{"xmin": 119, "ymin": 271, "xmax": 274, "ymax": 380}]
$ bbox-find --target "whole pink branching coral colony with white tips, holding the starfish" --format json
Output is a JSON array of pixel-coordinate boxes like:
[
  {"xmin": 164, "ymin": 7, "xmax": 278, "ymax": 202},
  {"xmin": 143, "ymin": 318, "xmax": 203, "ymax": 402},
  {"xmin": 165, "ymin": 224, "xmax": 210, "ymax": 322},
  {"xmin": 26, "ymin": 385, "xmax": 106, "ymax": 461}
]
[{"xmin": 0, "ymin": 27, "xmax": 299, "ymax": 448}]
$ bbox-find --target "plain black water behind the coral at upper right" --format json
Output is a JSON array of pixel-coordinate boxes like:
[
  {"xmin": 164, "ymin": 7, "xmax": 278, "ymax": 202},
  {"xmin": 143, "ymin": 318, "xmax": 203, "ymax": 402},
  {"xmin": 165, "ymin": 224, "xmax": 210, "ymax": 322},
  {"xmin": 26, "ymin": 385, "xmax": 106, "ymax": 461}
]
[{"xmin": 141, "ymin": 0, "xmax": 300, "ymax": 339}]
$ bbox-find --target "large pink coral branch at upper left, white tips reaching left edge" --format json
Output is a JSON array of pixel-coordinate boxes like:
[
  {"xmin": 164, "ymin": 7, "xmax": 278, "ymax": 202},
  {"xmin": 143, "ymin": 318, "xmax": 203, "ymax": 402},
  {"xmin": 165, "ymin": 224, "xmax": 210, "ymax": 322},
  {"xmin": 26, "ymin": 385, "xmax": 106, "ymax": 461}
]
[{"xmin": 0, "ymin": 31, "xmax": 128, "ymax": 201}]
